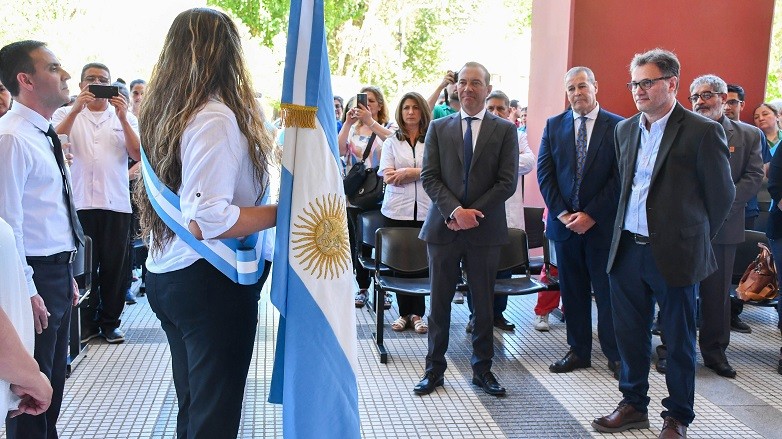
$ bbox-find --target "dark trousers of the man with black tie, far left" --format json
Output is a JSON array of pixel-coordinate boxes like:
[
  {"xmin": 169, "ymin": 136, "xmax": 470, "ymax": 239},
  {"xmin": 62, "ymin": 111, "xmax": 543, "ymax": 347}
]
[{"xmin": 6, "ymin": 261, "xmax": 73, "ymax": 439}]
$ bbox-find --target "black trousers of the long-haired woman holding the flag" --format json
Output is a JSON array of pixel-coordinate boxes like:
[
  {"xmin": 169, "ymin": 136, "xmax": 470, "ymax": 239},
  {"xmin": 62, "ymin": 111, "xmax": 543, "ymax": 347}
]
[{"xmin": 146, "ymin": 259, "xmax": 271, "ymax": 439}]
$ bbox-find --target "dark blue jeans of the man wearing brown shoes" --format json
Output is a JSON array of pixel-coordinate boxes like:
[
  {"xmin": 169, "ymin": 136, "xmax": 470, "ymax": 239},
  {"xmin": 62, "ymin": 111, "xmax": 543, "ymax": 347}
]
[{"xmin": 609, "ymin": 236, "xmax": 698, "ymax": 425}]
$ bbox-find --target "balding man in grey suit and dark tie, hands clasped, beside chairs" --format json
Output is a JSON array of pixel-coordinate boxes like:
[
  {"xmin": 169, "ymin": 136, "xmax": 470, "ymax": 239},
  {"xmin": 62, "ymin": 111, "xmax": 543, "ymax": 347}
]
[{"xmin": 413, "ymin": 62, "xmax": 519, "ymax": 396}]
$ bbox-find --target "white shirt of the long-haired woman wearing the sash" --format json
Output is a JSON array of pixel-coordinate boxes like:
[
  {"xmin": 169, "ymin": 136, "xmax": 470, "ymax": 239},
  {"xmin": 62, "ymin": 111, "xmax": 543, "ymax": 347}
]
[{"xmin": 147, "ymin": 99, "xmax": 271, "ymax": 273}]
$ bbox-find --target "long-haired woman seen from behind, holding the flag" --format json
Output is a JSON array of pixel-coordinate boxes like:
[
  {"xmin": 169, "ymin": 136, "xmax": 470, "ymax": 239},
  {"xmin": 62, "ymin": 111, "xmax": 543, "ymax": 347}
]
[{"xmin": 135, "ymin": 8, "xmax": 277, "ymax": 438}]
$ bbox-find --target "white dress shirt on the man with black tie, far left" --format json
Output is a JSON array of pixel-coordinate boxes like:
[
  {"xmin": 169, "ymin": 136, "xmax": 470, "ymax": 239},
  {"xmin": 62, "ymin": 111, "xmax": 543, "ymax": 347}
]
[{"xmin": 0, "ymin": 101, "xmax": 76, "ymax": 296}]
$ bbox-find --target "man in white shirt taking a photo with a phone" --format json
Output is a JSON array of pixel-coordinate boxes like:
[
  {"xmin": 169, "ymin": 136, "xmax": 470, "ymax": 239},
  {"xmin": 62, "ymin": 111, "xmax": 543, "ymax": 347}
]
[{"xmin": 52, "ymin": 63, "xmax": 140, "ymax": 343}]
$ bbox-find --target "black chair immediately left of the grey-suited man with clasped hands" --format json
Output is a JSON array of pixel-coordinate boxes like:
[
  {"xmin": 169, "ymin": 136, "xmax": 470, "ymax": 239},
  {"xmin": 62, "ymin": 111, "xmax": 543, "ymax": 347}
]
[{"xmin": 374, "ymin": 227, "xmax": 429, "ymax": 363}]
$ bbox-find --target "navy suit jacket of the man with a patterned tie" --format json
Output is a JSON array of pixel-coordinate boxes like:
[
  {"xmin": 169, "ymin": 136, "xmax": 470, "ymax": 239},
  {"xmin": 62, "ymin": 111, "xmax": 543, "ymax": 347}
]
[{"xmin": 538, "ymin": 108, "xmax": 622, "ymax": 248}]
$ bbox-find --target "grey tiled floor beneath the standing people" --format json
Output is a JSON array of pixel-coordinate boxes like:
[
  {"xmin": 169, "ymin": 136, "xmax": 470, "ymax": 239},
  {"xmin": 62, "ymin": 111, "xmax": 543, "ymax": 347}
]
[{"xmin": 0, "ymin": 280, "xmax": 782, "ymax": 438}]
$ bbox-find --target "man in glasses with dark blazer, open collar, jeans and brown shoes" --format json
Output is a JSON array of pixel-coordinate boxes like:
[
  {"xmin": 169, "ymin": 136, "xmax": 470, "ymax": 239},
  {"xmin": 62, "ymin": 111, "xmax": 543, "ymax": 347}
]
[{"xmin": 592, "ymin": 49, "xmax": 735, "ymax": 438}]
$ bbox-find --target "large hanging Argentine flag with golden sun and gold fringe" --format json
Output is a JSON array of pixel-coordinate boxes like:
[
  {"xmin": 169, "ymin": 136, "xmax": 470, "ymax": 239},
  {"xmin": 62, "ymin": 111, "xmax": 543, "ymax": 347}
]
[{"xmin": 269, "ymin": 0, "xmax": 360, "ymax": 438}]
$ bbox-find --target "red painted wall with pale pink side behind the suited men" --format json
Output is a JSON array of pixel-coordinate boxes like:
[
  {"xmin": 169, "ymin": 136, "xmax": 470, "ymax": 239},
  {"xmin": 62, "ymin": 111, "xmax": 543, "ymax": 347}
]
[{"xmin": 525, "ymin": 0, "xmax": 774, "ymax": 210}]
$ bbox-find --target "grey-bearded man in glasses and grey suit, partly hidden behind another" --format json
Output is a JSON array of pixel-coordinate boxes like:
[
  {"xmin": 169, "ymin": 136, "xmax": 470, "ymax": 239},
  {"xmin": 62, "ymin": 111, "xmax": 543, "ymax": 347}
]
[{"xmin": 689, "ymin": 75, "xmax": 763, "ymax": 378}]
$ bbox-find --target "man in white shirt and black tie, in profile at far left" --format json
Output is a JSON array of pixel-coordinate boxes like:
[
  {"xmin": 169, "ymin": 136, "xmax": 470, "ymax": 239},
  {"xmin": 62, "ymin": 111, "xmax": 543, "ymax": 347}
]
[{"xmin": 0, "ymin": 41, "xmax": 84, "ymax": 439}]
